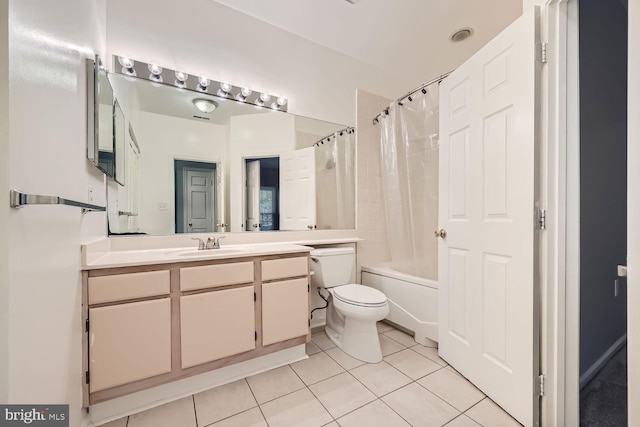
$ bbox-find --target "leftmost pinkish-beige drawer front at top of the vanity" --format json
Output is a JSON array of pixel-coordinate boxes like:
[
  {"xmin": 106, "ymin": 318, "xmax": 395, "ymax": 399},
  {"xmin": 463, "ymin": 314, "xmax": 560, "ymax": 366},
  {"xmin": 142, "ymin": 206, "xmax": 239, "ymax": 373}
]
[{"xmin": 88, "ymin": 270, "xmax": 169, "ymax": 304}]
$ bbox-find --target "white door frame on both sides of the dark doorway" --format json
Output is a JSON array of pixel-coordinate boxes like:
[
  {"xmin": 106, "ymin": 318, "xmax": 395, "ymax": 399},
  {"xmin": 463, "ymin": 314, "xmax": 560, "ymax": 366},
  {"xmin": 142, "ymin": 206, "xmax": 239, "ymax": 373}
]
[{"xmin": 542, "ymin": 0, "xmax": 640, "ymax": 426}]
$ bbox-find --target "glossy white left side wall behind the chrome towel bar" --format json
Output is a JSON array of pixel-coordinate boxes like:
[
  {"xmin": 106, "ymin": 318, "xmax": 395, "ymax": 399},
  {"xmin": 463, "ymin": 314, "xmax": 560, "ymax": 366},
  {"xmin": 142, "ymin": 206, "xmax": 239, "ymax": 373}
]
[{"xmin": 0, "ymin": 0, "xmax": 106, "ymax": 426}]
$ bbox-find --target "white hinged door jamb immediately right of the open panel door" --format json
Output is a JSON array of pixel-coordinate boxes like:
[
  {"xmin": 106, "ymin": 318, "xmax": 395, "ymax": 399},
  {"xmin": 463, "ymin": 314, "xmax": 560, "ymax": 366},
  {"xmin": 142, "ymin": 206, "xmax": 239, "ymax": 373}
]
[{"xmin": 524, "ymin": 0, "xmax": 579, "ymax": 426}]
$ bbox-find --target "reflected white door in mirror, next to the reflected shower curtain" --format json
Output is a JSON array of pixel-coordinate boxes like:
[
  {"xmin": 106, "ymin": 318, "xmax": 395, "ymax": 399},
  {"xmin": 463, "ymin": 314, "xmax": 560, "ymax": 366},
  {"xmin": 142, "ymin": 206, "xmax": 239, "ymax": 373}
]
[{"xmin": 280, "ymin": 147, "xmax": 316, "ymax": 230}]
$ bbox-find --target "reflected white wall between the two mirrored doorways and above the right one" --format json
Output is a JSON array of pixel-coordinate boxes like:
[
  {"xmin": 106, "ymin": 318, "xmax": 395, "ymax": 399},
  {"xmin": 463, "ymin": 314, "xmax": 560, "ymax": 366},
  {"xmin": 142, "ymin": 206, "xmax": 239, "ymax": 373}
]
[{"xmin": 229, "ymin": 114, "xmax": 296, "ymax": 231}]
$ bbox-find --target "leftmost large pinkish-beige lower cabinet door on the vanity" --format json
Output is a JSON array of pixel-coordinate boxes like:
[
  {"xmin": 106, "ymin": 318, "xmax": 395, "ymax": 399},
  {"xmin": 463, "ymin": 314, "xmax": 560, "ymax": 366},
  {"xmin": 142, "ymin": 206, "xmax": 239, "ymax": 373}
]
[{"xmin": 89, "ymin": 298, "xmax": 171, "ymax": 393}]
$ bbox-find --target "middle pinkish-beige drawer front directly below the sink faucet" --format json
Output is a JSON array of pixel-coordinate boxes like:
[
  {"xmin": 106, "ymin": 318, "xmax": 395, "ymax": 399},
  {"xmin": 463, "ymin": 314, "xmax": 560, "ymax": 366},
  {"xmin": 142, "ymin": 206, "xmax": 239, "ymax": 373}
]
[{"xmin": 180, "ymin": 261, "xmax": 253, "ymax": 292}]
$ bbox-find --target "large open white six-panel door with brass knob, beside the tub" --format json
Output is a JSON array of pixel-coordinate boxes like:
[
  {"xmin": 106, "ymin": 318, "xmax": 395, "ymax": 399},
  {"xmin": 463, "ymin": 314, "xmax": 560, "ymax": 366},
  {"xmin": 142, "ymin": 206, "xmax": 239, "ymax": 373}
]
[{"xmin": 438, "ymin": 14, "xmax": 538, "ymax": 426}]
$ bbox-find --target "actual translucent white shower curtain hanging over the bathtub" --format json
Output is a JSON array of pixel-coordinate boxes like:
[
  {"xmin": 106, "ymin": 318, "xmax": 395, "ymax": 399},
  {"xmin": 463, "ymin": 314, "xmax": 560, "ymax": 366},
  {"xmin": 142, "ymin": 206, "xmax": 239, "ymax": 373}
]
[{"xmin": 380, "ymin": 83, "xmax": 439, "ymax": 280}]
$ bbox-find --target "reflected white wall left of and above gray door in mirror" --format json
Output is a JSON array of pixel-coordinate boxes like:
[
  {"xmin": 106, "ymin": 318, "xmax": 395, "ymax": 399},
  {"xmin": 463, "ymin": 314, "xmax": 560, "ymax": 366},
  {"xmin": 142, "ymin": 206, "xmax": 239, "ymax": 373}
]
[{"xmin": 134, "ymin": 112, "xmax": 229, "ymax": 235}]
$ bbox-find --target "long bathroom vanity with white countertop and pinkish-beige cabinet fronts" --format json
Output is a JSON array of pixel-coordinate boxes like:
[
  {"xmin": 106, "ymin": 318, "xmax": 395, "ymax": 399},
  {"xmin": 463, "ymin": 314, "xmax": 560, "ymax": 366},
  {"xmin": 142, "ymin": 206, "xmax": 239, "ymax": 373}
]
[{"xmin": 83, "ymin": 244, "xmax": 311, "ymax": 407}]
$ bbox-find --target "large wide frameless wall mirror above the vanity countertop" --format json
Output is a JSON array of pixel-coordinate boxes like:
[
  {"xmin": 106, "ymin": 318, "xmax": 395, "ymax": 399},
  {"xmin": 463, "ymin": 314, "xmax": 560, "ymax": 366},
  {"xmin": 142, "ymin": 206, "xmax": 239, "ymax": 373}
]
[{"xmin": 108, "ymin": 74, "xmax": 355, "ymax": 235}]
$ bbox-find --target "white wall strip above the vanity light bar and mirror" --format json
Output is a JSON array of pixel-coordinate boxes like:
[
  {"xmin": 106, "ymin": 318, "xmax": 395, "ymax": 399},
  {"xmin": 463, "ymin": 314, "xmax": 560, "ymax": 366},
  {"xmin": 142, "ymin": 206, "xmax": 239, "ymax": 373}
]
[{"xmin": 107, "ymin": 0, "xmax": 404, "ymax": 125}]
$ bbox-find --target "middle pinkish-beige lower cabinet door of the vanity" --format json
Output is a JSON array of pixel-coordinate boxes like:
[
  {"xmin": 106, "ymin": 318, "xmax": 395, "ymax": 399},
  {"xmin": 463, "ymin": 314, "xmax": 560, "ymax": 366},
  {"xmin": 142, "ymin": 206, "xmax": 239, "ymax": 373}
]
[{"xmin": 180, "ymin": 286, "xmax": 256, "ymax": 369}]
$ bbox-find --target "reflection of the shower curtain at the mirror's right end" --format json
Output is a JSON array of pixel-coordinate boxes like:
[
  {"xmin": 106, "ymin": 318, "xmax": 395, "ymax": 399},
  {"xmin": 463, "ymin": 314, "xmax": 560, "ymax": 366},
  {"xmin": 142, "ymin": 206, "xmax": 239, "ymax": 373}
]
[{"xmin": 316, "ymin": 130, "xmax": 355, "ymax": 230}]
